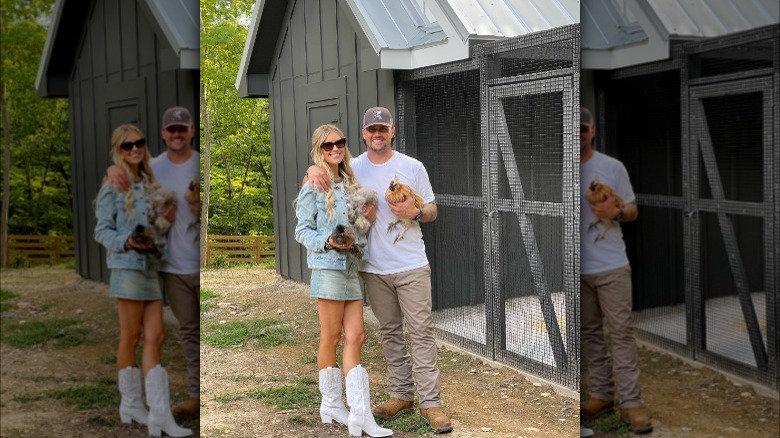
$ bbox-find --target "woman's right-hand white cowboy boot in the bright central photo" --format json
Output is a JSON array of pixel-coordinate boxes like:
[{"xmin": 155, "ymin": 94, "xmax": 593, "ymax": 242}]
[{"xmin": 347, "ymin": 365, "xmax": 393, "ymax": 437}]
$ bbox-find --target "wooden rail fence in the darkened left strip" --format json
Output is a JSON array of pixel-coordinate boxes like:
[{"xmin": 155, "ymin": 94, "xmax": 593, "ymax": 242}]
[{"xmin": 8, "ymin": 234, "xmax": 76, "ymax": 265}]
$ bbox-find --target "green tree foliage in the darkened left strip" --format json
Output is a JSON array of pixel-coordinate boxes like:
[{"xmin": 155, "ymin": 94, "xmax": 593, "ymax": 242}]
[{"xmin": 0, "ymin": 0, "xmax": 73, "ymax": 234}]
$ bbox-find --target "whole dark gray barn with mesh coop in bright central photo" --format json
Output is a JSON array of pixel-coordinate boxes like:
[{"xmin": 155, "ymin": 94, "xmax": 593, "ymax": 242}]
[{"xmin": 236, "ymin": 0, "xmax": 579, "ymax": 390}]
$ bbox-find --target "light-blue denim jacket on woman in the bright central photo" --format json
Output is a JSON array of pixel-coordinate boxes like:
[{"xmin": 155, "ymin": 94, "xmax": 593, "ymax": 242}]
[{"xmin": 295, "ymin": 182, "xmax": 368, "ymax": 270}]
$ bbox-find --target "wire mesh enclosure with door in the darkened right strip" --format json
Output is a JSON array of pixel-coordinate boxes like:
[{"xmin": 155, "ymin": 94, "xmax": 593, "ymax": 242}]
[{"xmin": 598, "ymin": 26, "xmax": 780, "ymax": 389}]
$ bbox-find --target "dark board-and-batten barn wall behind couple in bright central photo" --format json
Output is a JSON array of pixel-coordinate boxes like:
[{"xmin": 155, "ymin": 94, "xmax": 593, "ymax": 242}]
[{"xmin": 269, "ymin": 0, "xmax": 395, "ymax": 282}]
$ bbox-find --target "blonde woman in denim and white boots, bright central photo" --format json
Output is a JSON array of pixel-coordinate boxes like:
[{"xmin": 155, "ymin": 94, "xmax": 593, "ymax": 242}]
[{"xmin": 295, "ymin": 125, "xmax": 393, "ymax": 437}]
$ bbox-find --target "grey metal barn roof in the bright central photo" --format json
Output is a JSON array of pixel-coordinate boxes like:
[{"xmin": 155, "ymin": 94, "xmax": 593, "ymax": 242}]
[{"xmin": 236, "ymin": 0, "xmax": 580, "ymax": 97}]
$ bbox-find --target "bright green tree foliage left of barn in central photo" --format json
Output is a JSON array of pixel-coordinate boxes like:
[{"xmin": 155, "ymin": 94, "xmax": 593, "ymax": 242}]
[{"xmin": 200, "ymin": 0, "xmax": 273, "ymax": 235}]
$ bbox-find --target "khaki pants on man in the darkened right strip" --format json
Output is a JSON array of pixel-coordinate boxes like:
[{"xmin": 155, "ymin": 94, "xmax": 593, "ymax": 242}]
[{"xmin": 580, "ymin": 266, "xmax": 642, "ymax": 408}]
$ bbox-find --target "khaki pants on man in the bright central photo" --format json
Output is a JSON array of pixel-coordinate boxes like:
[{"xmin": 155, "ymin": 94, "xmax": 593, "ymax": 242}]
[{"xmin": 360, "ymin": 266, "xmax": 441, "ymax": 408}]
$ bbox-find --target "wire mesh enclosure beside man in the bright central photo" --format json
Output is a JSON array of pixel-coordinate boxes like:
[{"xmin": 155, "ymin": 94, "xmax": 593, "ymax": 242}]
[{"xmin": 397, "ymin": 25, "xmax": 580, "ymax": 390}]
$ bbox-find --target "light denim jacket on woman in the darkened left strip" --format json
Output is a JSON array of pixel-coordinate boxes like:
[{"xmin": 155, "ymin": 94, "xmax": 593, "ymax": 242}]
[{"xmin": 94, "ymin": 182, "xmax": 166, "ymax": 271}]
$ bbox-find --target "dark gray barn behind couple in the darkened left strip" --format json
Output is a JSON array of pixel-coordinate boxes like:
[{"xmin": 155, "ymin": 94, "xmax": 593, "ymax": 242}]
[{"xmin": 36, "ymin": 0, "xmax": 200, "ymax": 281}]
